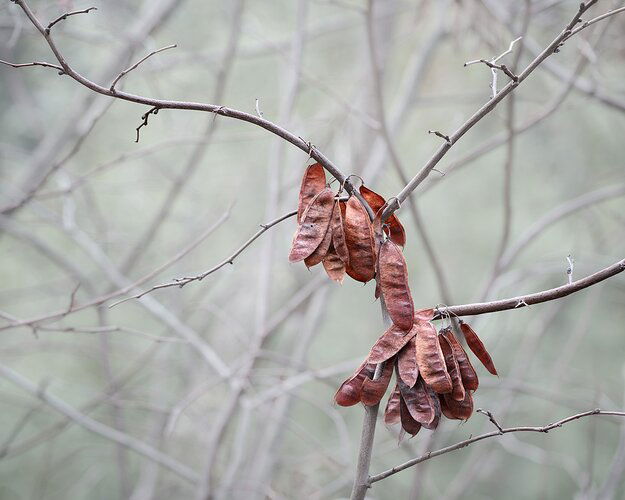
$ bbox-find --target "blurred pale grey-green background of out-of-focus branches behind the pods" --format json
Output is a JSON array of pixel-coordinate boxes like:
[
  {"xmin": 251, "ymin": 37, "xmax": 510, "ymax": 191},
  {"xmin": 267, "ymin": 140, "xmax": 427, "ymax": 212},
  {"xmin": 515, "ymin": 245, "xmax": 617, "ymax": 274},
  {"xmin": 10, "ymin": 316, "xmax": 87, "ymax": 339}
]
[{"xmin": 0, "ymin": 0, "xmax": 625, "ymax": 500}]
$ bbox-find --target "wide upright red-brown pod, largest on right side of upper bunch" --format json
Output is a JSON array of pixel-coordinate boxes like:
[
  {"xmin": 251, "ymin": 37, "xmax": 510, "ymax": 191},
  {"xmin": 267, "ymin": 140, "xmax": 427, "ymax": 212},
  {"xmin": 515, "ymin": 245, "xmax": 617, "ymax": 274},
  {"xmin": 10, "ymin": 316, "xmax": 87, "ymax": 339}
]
[{"xmin": 344, "ymin": 196, "xmax": 375, "ymax": 283}]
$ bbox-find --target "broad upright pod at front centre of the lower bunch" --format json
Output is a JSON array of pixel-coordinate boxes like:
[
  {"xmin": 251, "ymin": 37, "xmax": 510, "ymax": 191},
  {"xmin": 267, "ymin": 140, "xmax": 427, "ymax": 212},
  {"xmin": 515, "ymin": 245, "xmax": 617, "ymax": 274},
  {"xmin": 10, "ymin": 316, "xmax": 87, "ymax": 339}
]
[{"xmin": 415, "ymin": 321, "xmax": 453, "ymax": 394}]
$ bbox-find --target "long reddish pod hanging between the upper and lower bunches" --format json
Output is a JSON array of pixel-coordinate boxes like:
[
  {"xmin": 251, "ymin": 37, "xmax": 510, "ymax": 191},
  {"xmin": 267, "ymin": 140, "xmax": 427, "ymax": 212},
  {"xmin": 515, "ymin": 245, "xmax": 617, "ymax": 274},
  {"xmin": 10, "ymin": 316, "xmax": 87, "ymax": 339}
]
[{"xmin": 378, "ymin": 240, "xmax": 414, "ymax": 331}]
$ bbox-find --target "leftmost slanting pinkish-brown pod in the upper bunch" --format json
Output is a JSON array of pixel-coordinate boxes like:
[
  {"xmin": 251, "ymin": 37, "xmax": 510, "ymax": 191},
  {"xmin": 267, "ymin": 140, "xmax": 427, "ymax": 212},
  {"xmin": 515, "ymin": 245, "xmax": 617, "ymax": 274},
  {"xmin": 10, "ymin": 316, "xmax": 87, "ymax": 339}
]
[{"xmin": 289, "ymin": 188, "xmax": 334, "ymax": 262}]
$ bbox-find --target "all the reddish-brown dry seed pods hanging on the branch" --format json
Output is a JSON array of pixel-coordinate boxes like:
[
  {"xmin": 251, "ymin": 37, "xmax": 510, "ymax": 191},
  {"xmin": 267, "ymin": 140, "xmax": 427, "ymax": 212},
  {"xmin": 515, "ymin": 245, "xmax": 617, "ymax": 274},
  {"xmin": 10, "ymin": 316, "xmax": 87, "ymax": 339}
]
[{"xmin": 289, "ymin": 163, "xmax": 497, "ymax": 436}]
